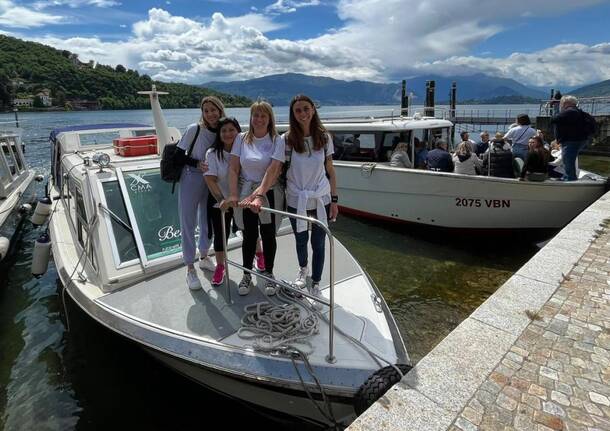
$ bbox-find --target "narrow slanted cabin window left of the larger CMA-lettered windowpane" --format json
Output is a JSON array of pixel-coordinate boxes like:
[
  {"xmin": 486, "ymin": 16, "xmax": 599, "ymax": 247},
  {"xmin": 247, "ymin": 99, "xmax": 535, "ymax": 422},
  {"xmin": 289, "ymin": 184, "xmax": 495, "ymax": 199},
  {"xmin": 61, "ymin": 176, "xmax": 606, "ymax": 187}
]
[{"xmin": 102, "ymin": 180, "xmax": 139, "ymax": 266}]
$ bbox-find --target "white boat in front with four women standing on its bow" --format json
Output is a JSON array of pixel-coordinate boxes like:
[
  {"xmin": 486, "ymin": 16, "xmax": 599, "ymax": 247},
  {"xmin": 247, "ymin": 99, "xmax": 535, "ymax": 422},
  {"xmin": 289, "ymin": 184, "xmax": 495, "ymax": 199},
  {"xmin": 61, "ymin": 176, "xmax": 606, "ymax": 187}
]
[{"xmin": 49, "ymin": 88, "xmax": 409, "ymax": 424}]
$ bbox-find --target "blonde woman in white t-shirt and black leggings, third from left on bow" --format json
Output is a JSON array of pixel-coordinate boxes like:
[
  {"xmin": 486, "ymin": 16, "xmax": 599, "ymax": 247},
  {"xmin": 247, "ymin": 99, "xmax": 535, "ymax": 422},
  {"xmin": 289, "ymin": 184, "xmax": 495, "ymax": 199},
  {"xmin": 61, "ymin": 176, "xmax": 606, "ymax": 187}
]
[{"xmin": 226, "ymin": 101, "xmax": 285, "ymax": 295}]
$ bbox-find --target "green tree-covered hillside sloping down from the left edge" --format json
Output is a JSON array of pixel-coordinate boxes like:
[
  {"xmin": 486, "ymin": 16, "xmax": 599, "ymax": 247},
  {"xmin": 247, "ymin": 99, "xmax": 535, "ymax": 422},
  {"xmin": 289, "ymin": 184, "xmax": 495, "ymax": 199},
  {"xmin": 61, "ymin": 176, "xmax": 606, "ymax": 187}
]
[{"xmin": 0, "ymin": 35, "xmax": 250, "ymax": 109}]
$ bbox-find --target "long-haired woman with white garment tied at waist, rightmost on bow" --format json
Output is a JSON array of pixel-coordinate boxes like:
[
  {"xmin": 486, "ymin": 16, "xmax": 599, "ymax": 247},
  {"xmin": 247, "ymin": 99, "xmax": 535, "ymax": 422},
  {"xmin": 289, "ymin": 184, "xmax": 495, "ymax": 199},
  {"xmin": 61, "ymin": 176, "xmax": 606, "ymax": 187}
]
[{"xmin": 284, "ymin": 94, "xmax": 339, "ymax": 306}]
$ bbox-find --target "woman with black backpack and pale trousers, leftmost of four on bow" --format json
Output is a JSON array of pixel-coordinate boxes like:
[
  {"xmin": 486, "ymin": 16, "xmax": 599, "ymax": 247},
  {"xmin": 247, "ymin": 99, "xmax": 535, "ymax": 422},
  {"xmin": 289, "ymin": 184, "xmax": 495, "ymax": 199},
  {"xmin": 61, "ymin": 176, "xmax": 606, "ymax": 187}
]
[{"xmin": 177, "ymin": 96, "xmax": 225, "ymax": 290}]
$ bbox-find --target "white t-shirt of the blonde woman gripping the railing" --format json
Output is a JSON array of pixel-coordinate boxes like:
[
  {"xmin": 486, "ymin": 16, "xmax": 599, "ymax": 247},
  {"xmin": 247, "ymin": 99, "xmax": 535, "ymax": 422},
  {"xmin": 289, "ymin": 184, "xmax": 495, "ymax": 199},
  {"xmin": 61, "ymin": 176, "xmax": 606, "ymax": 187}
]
[{"xmin": 231, "ymin": 132, "xmax": 285, "ymax": 183}]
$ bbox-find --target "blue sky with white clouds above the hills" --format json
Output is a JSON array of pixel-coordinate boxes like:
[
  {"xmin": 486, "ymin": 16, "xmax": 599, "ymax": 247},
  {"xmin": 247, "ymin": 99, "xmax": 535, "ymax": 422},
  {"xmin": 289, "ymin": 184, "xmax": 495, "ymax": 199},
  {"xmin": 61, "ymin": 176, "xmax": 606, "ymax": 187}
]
[{"xmin": 0, "ymin": 0, "xmax": 610, "ymax": 86}]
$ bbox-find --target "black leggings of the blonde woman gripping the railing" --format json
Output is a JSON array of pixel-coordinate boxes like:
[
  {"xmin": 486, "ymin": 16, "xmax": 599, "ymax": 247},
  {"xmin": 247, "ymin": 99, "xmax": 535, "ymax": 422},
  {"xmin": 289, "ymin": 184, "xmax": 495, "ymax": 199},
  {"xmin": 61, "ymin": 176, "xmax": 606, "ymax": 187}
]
[{"xmin": 241, "ymin": 190, "xmax": 277, "ymax": 274}]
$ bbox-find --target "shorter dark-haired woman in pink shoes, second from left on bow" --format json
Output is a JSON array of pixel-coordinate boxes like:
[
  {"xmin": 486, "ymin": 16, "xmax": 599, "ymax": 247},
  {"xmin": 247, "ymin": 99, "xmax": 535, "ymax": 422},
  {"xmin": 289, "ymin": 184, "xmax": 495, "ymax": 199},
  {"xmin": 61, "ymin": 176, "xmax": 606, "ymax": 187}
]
[{"xmin": 203, "ymin": 117, "xmax": 241, "ymax": 286}]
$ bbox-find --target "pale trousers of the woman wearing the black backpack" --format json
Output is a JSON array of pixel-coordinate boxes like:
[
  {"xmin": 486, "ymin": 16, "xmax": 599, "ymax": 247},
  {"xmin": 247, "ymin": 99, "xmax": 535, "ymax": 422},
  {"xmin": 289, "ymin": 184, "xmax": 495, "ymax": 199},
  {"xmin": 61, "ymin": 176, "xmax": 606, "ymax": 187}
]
[{"xmin": 179, "ymin": 166, "xmax": 210, "ymax": 265}]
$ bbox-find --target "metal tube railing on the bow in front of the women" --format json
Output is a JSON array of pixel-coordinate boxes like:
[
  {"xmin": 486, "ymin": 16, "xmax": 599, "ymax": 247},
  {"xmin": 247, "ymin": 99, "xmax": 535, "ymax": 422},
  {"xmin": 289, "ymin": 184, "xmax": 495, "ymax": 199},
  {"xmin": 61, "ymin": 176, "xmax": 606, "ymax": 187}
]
[{"xmin": 220, "ymin": 207, "xmax": 336, "ymax": 363}]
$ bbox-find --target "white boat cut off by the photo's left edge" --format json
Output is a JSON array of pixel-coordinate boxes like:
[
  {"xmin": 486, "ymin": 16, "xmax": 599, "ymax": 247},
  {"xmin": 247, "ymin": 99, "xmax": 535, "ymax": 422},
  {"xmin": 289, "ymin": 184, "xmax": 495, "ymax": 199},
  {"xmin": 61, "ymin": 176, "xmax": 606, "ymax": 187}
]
[{"xmin": 0, "ymin": 125, "xmax": 36, "ymax": 260}]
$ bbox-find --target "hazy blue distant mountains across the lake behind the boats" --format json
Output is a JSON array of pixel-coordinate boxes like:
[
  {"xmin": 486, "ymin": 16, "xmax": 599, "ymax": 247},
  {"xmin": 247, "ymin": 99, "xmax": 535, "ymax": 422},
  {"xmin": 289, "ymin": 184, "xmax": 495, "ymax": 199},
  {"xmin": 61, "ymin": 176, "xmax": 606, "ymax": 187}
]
[{"xmin": 202, "ymin": 73, "xmax": 546, "ymax": 106}]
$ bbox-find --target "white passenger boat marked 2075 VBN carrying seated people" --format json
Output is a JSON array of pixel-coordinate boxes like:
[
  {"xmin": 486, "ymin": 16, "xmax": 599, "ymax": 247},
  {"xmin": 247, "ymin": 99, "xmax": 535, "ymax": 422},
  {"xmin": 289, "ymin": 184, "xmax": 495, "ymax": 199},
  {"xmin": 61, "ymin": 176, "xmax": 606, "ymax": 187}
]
[{"xmin": 278, "ymin": 114, "xmax": 607, "ymax": 229}]
